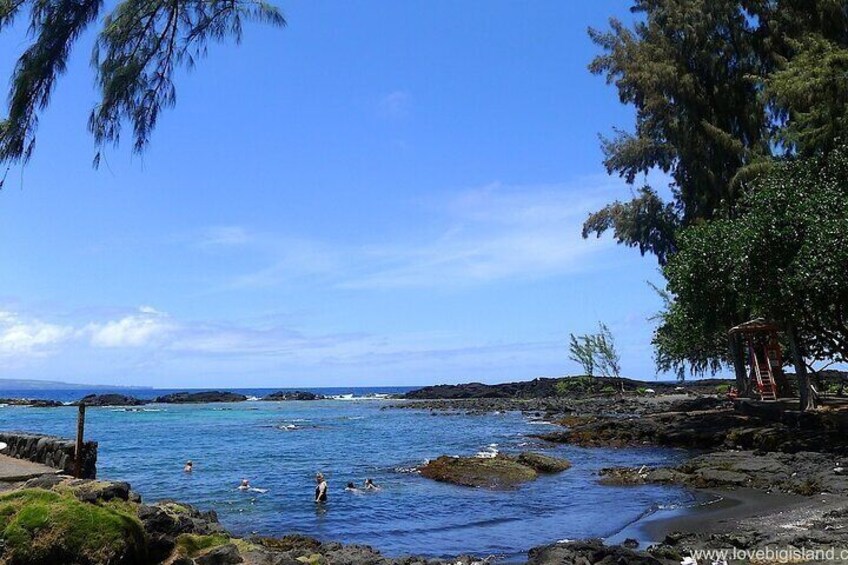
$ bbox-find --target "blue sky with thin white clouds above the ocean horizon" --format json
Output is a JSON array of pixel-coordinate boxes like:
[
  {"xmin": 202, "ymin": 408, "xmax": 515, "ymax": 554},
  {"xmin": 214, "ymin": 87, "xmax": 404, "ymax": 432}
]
[{"xmin": 0, "ymin": 0, "xmax": 684, "ymax": 387}]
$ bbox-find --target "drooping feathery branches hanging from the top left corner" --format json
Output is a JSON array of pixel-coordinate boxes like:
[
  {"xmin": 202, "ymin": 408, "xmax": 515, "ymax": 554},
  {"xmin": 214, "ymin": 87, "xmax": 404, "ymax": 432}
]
[{"xmin": 0, "ymin": 0, "xmax": 285, "ymax": 165}]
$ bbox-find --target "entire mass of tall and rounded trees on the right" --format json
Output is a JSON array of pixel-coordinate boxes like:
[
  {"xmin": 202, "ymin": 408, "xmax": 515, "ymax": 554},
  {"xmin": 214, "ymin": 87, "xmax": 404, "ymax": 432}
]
[{"xmin": 583, "ymin": 0, "xmax": 848, "ymax": 409}]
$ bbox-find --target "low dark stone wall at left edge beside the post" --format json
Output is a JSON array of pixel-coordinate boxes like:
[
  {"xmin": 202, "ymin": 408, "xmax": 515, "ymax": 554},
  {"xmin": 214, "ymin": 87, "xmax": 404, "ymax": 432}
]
[{"xmin": 0, "ymin": 432, "xmax": 97, "ymax": 479}]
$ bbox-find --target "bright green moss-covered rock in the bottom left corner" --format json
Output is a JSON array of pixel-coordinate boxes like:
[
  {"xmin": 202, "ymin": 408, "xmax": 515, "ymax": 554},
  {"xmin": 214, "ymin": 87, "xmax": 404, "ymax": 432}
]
[{"xmin": 0, "ymin": 489, "xmax": 147, "ymax": 565}]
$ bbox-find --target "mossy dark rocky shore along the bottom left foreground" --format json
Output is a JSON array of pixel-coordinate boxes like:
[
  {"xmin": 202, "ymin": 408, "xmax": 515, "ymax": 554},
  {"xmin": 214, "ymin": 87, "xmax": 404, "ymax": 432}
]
[{"xmin": 0, "ymin": 475, "xmax": 484, "ymax": 565}]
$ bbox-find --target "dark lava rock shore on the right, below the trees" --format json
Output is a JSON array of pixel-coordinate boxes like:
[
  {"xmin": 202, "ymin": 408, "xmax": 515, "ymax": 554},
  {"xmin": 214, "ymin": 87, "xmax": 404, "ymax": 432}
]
[{"xmin": 391, "ymin": 381, "xmax": 848, "ymax": 565}]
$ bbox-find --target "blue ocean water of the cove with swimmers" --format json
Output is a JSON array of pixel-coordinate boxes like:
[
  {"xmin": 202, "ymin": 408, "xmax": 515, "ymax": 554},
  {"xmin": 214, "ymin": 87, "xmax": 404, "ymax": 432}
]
[{"xmin": 0, "ymin": 388, "xmax": 693, "ymax": 561}]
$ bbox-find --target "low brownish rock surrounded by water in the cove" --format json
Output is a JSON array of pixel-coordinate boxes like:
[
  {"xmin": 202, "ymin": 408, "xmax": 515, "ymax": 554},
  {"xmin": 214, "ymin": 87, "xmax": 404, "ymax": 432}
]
[{"xmin": 420, "ymin": 452, "xmax": 571, "ymax": 489}]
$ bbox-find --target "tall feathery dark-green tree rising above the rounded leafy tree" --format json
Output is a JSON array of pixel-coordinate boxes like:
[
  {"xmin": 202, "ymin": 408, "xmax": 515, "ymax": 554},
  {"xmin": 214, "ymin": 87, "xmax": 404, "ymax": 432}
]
[{"xmin": 583, "ymin": 0, "xmax": 848, "ymax": 265}]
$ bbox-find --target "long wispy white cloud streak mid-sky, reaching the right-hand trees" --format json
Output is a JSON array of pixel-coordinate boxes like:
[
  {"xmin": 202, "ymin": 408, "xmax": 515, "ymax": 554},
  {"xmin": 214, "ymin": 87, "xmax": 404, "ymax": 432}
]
[{"xmin": 210, "ymin": 176, "xmax": 621, "ymax": 289}]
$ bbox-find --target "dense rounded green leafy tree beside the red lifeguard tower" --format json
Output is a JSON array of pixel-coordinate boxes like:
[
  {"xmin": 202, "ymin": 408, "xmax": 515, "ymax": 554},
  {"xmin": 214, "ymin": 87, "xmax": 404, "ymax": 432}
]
[{"xmin": 654, "ymin": 146, "xmax": 848, "ymax": 407}]
